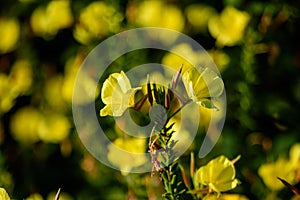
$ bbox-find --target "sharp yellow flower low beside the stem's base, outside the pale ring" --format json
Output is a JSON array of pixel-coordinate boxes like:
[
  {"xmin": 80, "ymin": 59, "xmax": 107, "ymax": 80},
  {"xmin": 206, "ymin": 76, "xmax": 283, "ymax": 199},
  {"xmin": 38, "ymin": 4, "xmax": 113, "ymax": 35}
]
[{"xmin": 194, "ymin": 156, "xmax": 239, "ymax": 193}]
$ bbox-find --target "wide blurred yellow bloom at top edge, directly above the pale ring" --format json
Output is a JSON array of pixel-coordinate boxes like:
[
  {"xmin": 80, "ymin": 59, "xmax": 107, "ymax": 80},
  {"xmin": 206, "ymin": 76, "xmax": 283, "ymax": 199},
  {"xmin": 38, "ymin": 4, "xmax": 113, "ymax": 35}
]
[{"xmin": 134, "ymin": 0, "xmax": 184, "ymax": 31}]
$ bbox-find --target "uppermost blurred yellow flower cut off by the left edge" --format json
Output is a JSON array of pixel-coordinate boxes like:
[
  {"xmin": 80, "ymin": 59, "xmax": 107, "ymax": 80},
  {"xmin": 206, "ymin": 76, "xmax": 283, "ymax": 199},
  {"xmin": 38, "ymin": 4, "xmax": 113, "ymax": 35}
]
[{"xmin": 0, "ymin": 18, "xmax": 20, "ymax": 54}]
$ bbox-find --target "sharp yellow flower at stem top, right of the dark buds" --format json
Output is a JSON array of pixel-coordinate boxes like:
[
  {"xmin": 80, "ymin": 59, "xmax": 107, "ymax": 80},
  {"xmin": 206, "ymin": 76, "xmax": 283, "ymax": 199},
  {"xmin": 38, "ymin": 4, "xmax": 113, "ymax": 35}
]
[{"xmin": 182, "ymin": 67, "xmax": 224, "ymax": 105}]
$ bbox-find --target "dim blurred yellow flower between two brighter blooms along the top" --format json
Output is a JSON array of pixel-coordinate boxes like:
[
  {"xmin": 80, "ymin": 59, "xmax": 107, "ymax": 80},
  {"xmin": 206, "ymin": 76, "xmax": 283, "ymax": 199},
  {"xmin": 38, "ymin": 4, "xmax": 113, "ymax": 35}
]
[{"xmin": 185, "ymin": 4, "xmax": 217, "ymax": 32}]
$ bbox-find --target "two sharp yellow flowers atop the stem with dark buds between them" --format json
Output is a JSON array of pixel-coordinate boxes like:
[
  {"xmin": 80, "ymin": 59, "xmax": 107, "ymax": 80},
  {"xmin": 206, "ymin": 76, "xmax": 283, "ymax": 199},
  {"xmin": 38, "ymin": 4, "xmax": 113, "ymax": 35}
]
[{"xmin": 100, "ymin": 67, "xmax": 224, "ymax": 117}]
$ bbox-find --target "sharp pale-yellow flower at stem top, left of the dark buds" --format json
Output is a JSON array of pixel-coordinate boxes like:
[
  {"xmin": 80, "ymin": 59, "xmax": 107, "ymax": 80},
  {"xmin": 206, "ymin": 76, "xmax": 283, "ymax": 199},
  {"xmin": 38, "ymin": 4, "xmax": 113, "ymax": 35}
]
[{"xmin": 100, "ymin": 71, "xmax": 140, "ymax": 116}]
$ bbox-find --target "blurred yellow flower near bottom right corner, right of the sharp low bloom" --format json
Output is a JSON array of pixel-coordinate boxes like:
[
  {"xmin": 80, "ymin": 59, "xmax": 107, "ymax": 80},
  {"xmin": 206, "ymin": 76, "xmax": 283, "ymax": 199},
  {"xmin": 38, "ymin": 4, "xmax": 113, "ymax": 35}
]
[{"xmin": 258, "ymin": 157, "xmax": 294, "ymax": 191}]
